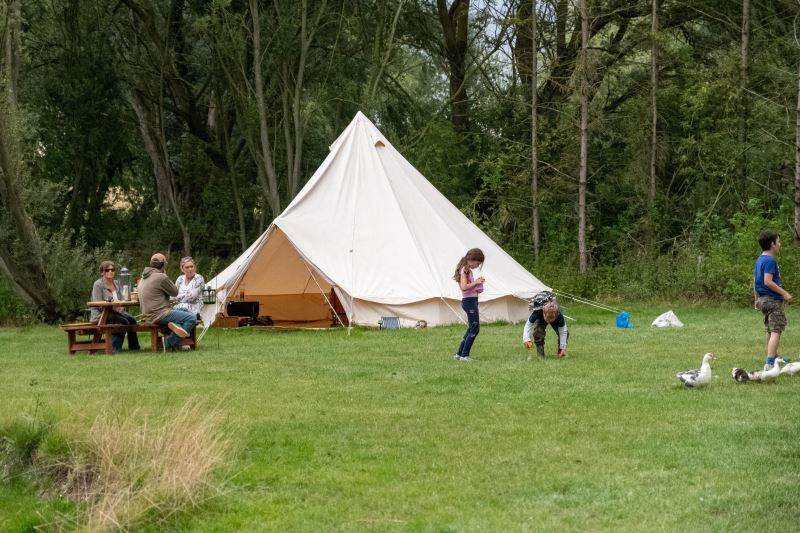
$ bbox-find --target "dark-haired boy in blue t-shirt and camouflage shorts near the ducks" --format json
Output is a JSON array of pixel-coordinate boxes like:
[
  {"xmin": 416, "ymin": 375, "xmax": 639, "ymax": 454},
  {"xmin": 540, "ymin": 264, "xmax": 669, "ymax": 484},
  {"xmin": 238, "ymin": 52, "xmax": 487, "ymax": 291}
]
[{"xmin": 753, "ymin": 231, "xmax": 792, "ymax": 365}]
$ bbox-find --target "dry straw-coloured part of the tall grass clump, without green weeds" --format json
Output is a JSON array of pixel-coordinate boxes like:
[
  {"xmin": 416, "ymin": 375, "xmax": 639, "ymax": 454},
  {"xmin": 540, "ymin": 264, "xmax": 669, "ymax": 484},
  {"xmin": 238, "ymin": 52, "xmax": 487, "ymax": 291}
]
[{"xmin": 84, "ymin": 401, "xmax": 229, "ymax": 530}]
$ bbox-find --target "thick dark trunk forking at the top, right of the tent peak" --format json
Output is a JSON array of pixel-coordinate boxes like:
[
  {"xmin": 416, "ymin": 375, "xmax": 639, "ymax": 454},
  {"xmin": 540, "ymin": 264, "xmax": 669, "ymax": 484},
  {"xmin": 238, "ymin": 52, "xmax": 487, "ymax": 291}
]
[{"xmin": 436, "ymin": 0, "xmax": 470, "ymax": 133}]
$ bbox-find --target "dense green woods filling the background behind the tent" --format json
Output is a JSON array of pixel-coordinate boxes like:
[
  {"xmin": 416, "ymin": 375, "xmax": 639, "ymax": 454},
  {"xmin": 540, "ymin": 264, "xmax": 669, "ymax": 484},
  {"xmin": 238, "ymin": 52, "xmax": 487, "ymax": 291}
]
[{"xmin": 0, "ymin": 0, "xmax": 800, "ymax": 320}]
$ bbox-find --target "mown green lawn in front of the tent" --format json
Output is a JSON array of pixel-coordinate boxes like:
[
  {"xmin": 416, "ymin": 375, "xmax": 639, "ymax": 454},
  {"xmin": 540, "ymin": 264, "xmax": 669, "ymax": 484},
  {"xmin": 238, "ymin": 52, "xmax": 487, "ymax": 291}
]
[{"xmin": 0, "ymin": 306, "xmax": 800, "ymax": 531}]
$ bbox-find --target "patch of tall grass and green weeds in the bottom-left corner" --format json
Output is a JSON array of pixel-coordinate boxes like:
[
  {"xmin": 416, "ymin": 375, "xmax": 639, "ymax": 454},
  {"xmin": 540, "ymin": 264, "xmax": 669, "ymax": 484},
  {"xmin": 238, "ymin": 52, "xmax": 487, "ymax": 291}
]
[{"xmin": 0, "ymin": 400, "xmax": 230, "ymax": 531}]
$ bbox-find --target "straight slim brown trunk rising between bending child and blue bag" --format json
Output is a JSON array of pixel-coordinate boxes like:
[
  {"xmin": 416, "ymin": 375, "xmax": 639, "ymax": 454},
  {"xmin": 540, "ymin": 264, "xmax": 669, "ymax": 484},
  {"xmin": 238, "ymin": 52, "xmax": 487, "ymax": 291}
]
[{"xmin": 578, "ymin": 0, "xmax": 589, "ymax": 272}]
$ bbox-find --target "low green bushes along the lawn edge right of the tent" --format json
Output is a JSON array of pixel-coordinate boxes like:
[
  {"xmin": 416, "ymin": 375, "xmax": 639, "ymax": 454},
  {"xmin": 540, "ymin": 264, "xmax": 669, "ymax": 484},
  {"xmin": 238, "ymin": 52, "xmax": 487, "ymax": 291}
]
[{"xmin": 520, "ymin": 200, "xmax": 800, "ymax": 305}]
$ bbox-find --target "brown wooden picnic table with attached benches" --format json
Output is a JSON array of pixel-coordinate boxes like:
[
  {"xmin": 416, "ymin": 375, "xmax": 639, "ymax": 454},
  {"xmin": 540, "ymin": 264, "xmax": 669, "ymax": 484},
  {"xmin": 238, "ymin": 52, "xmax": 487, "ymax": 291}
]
[{"xmin": 61, "ymin": 302, "xmax": 197, "ymax": 355}]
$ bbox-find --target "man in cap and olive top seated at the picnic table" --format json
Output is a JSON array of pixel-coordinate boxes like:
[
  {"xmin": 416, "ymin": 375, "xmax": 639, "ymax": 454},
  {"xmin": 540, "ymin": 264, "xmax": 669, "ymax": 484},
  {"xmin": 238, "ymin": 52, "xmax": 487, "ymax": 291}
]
[{"xmin": 139, "ymin": 253, "xmax": 197, "ymax": 352}]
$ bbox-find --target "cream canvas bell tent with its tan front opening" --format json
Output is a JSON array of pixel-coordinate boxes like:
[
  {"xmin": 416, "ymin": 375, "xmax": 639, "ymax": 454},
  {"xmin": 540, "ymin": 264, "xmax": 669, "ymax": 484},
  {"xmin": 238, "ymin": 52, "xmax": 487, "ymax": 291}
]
[{"xmin": 202, "ymin": 112, "xmax": 549, "ymax": 326}]
